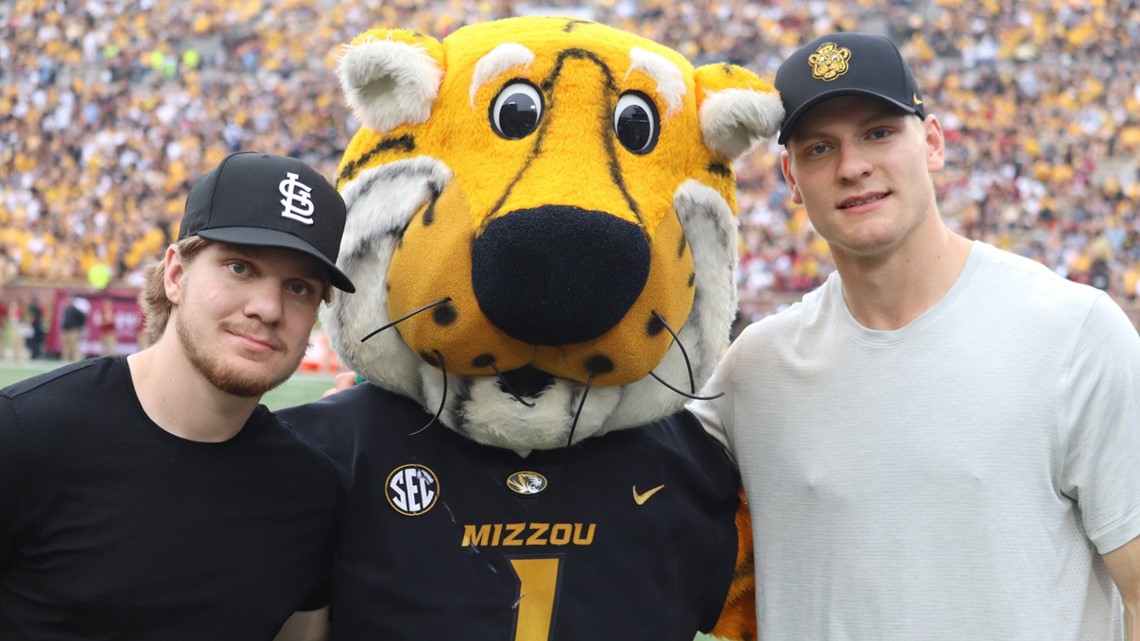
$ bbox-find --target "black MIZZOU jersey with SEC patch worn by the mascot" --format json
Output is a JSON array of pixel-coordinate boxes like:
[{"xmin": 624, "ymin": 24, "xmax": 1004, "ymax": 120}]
[{"xmin": 278, "ymin": 384, "xmax": 740, "ymax": 641}]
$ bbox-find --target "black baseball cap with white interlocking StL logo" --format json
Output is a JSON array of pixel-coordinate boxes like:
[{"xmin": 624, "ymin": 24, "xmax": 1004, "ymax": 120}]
[{"xmin": 178, "ymin": 152, "xmax": 356, "ymax": 292}]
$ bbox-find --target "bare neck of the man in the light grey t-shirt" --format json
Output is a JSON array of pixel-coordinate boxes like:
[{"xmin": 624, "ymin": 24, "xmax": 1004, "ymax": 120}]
[{"xmin": 836, "ymin": 218, "xmax": 972, "ymax": 331}]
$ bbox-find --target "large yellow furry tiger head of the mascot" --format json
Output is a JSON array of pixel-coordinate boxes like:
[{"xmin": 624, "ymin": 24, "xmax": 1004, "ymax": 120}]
[{"xmin": 321, "ymin": 17, "xmax": 783, "ymax": 449}]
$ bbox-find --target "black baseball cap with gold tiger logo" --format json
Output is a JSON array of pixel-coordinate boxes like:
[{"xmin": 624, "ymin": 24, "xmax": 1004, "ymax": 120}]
[{"xmin": 775, "ymin": 33, "xmax": 926, "ymax": 145}]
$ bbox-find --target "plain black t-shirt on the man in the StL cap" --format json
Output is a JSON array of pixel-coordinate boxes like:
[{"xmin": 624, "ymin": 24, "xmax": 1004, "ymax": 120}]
[{"xmin": 0, "ymin": 357, "xmax": 340, "ymax": 641}]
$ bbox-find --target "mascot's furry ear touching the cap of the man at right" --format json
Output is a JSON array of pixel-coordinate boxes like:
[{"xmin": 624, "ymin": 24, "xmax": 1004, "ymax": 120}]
[{"xmin": 693, "ymin": 63, "xmax": 784, "ymax": 161}]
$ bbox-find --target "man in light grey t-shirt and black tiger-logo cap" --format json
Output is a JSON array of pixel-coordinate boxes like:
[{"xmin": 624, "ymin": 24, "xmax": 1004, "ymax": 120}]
[{"xmin": 694, "ymin": 33, "xmax": 1140, "ymax": 641}]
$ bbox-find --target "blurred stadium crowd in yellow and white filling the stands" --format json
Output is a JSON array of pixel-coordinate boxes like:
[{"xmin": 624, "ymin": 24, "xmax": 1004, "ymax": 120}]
[{"xmin": 0, "ymin": 0, "xmax": 1140, "ymax": 323}]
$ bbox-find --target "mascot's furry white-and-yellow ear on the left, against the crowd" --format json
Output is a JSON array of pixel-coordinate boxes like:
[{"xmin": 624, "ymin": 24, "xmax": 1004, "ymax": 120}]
[{"xmin": 336, "ymin": 29, "xmax": 443, "ymax": 135}]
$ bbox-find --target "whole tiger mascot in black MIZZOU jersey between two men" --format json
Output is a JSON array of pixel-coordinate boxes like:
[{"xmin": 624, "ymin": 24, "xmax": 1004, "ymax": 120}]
[{"xmin": 286, "ymin": 17, "xmax": 783, "ymax": 641}]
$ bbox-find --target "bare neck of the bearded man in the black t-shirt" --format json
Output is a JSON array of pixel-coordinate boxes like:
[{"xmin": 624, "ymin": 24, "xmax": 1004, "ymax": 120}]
[{"xmin": 127, "ymin": 335, "xmax": 260, "ymax": 443}]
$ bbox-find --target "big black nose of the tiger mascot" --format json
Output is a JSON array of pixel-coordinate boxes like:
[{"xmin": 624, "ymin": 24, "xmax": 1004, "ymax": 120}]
[{"xmin": 471, "ymin": 206, "xmax": 650, "ymax": 346}]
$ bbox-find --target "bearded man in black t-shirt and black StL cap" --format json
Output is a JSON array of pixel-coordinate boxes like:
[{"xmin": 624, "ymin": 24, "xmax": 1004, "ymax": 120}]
[{"xmin": 0, "ymin": 153, "xmax": 353, "ymax": 641}]
